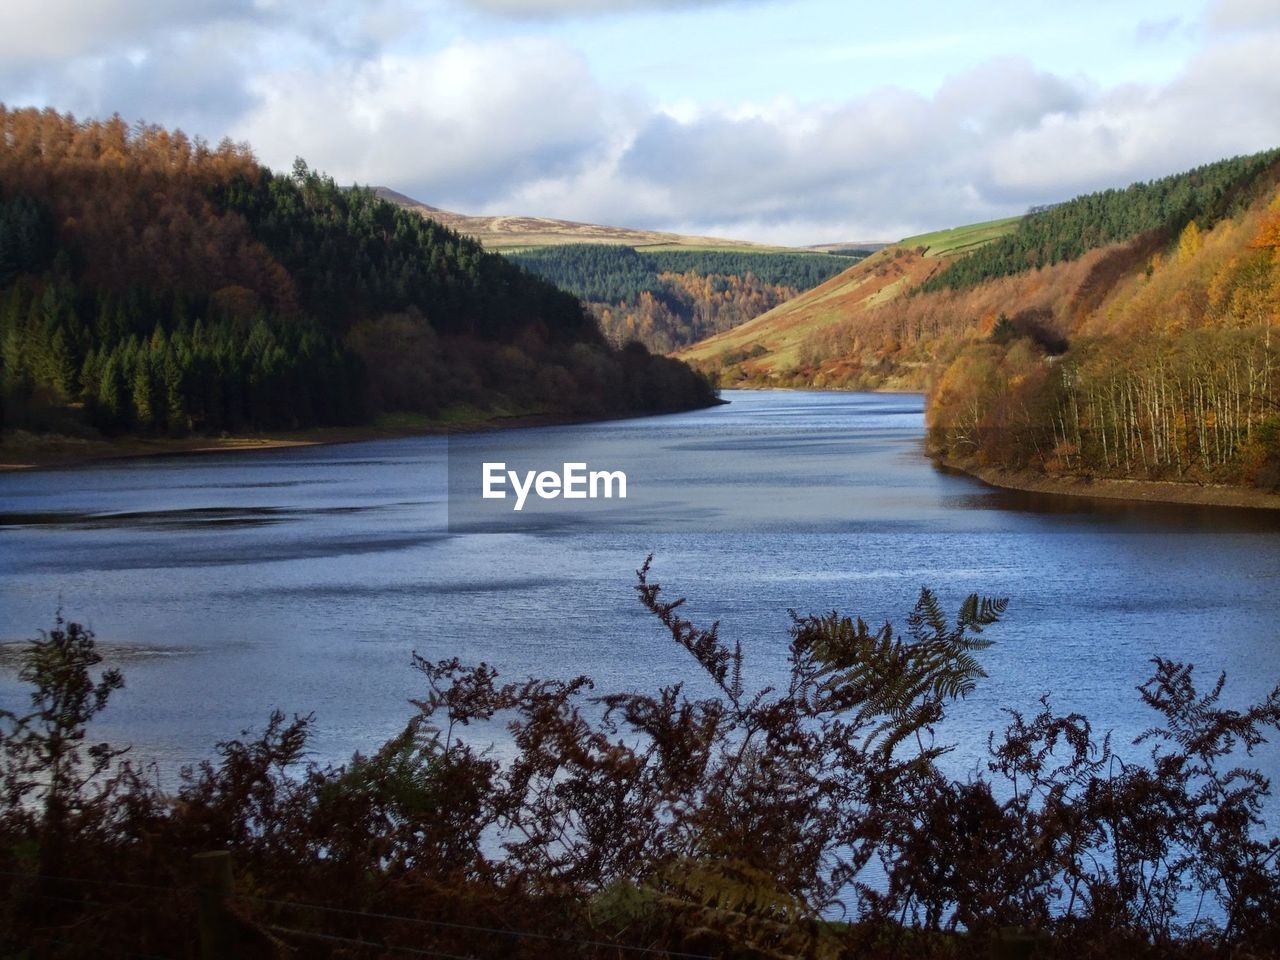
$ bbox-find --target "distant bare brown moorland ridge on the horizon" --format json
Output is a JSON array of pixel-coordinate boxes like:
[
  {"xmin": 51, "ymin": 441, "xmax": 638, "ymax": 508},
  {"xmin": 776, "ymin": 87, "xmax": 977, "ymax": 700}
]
[{"xmin": 374, "ymin": 187, "xmax": 786, "ymax": 251}]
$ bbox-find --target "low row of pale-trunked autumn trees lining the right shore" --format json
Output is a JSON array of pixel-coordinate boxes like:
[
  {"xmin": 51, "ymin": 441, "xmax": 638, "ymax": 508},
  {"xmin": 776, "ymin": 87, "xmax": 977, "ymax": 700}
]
[{"xmin": 929, "ymin": 329, "xmax": 1280, "ymax": 489}]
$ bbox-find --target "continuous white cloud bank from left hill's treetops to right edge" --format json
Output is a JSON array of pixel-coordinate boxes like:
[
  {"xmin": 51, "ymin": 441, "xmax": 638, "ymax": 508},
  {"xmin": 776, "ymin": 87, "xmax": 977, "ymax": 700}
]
[{"xmin": 237, "ymin": 35, "xmax": 1280, "ymax": 243}]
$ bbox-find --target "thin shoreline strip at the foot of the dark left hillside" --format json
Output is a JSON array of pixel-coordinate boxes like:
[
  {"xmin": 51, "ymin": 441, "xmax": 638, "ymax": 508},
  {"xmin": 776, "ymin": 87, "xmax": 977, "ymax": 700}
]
[{"xmin": 0, "ymin": 401, "xmax": 728, "ymax": 474}]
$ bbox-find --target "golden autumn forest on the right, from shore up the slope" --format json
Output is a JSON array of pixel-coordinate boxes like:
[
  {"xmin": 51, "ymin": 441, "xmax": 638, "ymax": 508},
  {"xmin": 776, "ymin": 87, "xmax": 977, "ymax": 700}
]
[{"xmin": 929, "ymin": 209, "xmax": 1280, "ymax": 490}]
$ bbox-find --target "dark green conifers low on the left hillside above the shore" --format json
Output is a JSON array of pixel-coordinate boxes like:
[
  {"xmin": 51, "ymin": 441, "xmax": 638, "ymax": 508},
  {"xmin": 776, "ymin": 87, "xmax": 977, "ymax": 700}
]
[{"xmin": 0, "ymin": 275, "xmax": 366, "ymax": 435}]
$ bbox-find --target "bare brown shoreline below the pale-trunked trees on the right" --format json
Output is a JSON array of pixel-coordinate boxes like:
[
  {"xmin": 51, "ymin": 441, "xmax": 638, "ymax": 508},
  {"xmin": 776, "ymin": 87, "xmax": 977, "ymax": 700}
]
[{"xmin": 933, "ymin": 458, "xmax": 1280, "ymax": 509}]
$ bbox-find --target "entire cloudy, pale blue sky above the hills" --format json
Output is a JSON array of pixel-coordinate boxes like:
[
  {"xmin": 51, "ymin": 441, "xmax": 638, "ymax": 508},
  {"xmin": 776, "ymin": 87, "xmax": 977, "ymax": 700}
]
[{"xmin": 0, "ymin": 0, "xmax": 1280, "ymax": 246}]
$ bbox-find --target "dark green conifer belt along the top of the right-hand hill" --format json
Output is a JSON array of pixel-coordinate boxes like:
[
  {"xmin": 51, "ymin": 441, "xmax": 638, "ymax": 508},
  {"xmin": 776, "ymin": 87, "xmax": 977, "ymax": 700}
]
[{"xmin": 919, "ymin": 150, "xmax": 1280, "ymax": 292}]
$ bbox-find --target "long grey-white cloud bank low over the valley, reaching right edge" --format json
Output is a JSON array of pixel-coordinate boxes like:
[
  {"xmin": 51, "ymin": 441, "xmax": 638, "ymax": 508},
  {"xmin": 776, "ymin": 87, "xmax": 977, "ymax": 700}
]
[{"xmin": 489, "ymin": 35, "xmax": 1280, "ymax": 243}]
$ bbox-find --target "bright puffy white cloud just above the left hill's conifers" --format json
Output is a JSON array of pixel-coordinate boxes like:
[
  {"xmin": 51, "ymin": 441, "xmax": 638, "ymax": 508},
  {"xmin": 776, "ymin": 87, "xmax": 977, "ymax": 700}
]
[{"xmin": 236, "ymin": 40, "xmax": 622, "ymax": 205}]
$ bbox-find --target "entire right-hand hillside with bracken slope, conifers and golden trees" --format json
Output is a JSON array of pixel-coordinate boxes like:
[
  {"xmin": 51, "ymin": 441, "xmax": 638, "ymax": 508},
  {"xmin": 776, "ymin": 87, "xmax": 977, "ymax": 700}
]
[{"xmin": 677, "ymin": 151, "xmax": 1280, "ymax": 488}]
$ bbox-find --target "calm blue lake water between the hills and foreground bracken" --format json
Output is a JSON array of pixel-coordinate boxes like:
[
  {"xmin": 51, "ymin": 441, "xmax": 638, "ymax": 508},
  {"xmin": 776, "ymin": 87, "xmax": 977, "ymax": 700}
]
[{"xmin": 0, "ymin": 392, "xmax": 1280, "ymax": 776}]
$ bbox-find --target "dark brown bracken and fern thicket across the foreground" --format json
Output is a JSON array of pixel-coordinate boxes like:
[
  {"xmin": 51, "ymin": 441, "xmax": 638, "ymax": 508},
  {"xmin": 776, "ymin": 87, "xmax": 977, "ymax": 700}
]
[{"xmin": 0, "ymin": 562, "xmax": 1280, "ymax": 960}]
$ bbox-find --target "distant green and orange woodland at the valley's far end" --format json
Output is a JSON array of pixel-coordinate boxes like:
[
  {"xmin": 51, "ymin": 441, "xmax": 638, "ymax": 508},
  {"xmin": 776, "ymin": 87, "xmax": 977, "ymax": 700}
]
[{"xmin": 508, "ymin": 243, "xmax": 859, "ymax": 353}]
